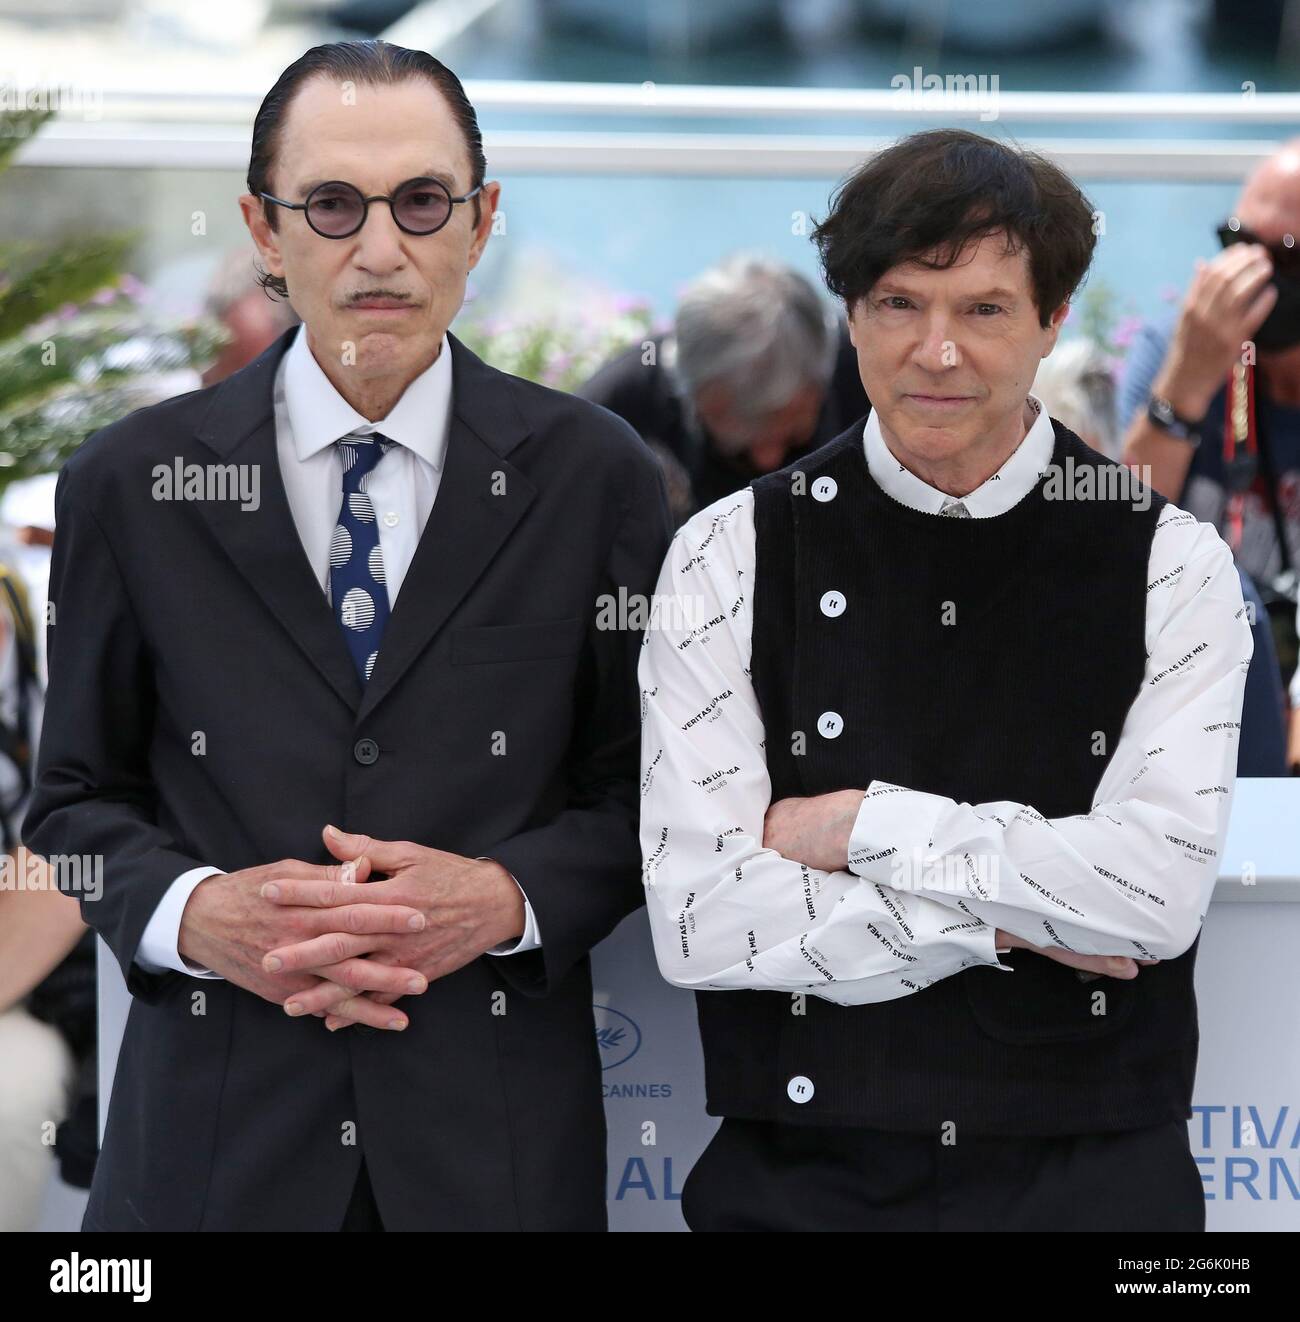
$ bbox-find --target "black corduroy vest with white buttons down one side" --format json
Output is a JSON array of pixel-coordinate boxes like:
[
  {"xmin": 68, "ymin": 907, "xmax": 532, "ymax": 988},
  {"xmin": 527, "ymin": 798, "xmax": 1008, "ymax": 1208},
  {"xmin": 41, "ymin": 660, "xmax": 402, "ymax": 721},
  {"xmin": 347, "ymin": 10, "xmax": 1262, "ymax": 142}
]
[{"xmin": 696, "ymin": 422, "xmax": 1198, "ymax": 1136}]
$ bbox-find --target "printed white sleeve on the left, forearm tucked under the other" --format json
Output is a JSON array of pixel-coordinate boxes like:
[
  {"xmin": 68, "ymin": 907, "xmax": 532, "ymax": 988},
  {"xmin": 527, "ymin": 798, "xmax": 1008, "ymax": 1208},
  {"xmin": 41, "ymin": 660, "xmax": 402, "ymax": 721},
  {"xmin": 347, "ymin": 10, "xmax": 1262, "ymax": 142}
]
[{"xmin": 639, "ymin": 490, "xmax": 1006, "ymax": 1005}]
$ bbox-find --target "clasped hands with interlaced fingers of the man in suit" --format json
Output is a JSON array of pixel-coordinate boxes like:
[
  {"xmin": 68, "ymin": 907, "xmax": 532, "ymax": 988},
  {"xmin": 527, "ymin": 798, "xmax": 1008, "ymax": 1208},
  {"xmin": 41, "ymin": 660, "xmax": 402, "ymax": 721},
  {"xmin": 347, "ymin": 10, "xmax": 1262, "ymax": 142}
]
[{"xmin": 180, "ymin": 826, "xmax": 524, "ymax": 1031}]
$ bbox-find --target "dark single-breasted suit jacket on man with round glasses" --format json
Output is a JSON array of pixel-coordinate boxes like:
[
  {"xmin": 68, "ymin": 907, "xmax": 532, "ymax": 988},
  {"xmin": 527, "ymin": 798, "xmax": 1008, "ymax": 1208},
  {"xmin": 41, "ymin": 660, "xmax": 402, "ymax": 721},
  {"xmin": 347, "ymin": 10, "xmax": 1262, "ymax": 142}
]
[{"xmin": 25, "ymin": 332, "xmax": 669, "ymax": 1229}]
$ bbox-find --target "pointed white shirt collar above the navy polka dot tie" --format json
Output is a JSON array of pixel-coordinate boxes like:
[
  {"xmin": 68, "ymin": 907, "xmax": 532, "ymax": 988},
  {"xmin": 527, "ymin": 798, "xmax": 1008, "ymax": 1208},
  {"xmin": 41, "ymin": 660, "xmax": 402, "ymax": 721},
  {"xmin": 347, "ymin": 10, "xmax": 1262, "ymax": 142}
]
[{"xmin": 284, "ymin": 327, "xmax": 451, "ymax": 469}]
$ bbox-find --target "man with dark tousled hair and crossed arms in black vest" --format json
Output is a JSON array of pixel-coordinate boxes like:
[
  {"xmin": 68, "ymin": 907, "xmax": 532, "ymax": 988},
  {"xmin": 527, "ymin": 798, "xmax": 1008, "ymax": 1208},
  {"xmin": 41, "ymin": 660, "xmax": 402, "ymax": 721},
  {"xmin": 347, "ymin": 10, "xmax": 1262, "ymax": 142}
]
[{"xmin": 640, "ymin": 130, "xmax": 1252, "ymax": 1229}]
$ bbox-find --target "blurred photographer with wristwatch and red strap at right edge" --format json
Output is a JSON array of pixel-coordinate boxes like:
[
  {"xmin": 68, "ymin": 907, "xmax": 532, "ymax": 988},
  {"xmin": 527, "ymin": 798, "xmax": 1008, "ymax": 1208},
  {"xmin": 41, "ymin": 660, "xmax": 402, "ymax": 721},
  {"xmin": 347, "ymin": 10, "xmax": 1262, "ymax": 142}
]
[{"xmin": 1120, "ymin": 139, "xmax": 1300, "ymax": 773}]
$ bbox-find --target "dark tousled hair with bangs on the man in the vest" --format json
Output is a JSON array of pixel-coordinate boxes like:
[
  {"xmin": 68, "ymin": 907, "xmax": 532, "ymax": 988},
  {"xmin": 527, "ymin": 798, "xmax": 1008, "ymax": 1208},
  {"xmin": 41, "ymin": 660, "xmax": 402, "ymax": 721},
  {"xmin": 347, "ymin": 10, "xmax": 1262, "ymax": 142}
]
[{"xmin": 812, "ymin": 128, "xmax": 1096, "ymax": 327}]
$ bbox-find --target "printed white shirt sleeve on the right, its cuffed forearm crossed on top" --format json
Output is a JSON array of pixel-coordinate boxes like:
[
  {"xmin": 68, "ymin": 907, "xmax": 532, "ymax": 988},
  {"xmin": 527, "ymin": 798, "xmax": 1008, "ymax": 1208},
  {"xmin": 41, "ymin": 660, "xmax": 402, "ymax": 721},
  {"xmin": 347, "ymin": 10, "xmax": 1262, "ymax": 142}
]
[{"xmin": 849, "ymin": 505, "xmax": 1254, "ymax": 960}]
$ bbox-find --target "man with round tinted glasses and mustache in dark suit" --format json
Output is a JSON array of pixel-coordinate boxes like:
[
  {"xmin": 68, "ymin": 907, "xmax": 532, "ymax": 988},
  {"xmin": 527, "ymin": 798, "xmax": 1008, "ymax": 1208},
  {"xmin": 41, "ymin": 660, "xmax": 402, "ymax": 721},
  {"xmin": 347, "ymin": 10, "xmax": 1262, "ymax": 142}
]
[{"xmin": 25, "ymin": 41, "xmax": 670, "ymax": 1229}]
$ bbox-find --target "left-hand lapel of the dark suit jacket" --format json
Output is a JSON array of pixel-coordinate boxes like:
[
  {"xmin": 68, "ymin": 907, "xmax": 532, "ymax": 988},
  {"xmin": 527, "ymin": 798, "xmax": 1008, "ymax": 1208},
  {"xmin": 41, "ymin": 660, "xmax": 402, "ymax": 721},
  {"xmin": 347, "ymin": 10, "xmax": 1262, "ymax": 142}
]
[{"xmin": 190, "ymin": 328, "xmax": 361, "ymax": 710}]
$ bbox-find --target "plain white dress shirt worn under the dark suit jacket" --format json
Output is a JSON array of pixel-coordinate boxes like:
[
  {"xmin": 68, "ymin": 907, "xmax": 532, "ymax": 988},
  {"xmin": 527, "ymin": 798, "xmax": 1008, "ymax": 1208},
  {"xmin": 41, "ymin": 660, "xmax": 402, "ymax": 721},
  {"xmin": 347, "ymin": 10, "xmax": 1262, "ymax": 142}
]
[{"xmin": 135, "ymin": 327, "xmax": 541, "ymax": 978}]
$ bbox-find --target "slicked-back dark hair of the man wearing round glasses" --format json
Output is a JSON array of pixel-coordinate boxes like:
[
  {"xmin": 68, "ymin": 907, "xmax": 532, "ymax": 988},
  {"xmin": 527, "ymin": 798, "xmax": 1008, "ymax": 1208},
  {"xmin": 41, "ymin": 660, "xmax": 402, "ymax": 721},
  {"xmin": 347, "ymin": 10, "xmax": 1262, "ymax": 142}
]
[{"xmin": 247, "ymin": 40, "xmax": 488, "ymax": 299}]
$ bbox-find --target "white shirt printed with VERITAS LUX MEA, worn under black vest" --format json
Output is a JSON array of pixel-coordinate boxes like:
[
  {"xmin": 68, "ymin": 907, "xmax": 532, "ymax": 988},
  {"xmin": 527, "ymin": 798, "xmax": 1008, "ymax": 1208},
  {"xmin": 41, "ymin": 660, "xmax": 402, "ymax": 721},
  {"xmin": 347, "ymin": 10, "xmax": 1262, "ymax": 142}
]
[{"xmin": 639, "ymin": 397, "xmax": 1254, "ymax": 1005}]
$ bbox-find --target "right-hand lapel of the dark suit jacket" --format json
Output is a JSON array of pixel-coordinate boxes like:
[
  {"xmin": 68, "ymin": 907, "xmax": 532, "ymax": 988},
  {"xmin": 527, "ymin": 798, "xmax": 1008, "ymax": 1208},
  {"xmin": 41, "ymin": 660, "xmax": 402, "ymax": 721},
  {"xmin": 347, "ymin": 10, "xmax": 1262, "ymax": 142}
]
[{"xmin": 357, "ymin": 336, "xmax": 536, "ymax": 720}]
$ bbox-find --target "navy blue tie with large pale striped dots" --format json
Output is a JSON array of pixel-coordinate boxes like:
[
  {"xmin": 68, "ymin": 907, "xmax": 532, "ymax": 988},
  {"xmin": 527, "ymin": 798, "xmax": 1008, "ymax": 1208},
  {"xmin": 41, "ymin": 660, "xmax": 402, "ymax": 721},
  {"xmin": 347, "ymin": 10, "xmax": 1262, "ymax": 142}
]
[{"xmin": 329, "ymin": 432, "xmax": 395, "ymax": 683}]
